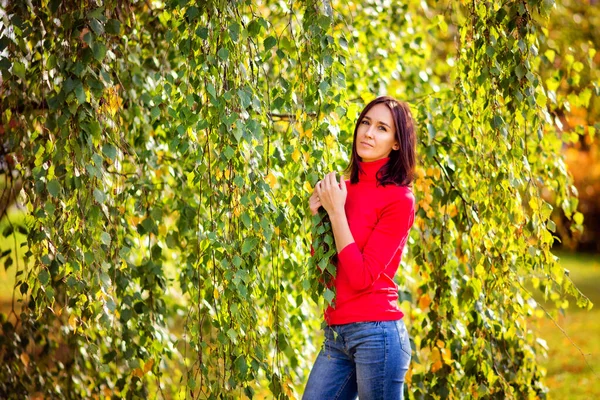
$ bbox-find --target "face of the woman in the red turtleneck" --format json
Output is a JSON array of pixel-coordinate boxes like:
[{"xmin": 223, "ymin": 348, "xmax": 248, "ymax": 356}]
[{"xmin": 356, "ymin": 104, "xmax": 400, "ymax": 162}]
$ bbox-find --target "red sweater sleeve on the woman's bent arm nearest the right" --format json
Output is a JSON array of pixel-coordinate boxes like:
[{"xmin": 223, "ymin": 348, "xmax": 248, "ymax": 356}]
[{"xmin": 338, "ymin": 191, "xmax": 415, "ymax": 291}]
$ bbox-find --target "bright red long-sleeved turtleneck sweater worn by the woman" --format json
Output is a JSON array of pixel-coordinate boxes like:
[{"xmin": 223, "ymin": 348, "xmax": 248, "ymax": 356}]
[{"xmin": 325, "ymin": 157, "xmax": 415, "ymax": 325}]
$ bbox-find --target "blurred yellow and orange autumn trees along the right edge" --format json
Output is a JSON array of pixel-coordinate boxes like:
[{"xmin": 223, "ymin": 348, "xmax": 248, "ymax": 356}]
[{"xmin": 540, "ymin": 1, "xmax": 600, "ymax": 251}]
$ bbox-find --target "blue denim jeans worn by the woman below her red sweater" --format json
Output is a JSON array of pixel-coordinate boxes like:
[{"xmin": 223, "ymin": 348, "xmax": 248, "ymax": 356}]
[{"xmin": 302, "ymin": 319, "xmax": 411, "ymax": 400}]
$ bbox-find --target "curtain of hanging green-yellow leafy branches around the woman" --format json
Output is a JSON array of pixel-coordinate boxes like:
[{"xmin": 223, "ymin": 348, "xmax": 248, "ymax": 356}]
[{"xmin": 0, "ymin": 0, "xmax": 591, "ymax": 398}]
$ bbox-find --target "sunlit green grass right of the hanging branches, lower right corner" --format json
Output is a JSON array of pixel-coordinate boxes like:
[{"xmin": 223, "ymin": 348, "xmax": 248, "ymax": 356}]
[{"xmin": 535, "ymin": 253, "xmax": 600, "ymax": 399}]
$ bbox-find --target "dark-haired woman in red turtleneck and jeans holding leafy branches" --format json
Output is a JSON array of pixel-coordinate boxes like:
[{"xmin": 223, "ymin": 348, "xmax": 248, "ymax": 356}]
[{"xmin": 303, "ymin": 96, "xmax": 415, "ymax": 400}]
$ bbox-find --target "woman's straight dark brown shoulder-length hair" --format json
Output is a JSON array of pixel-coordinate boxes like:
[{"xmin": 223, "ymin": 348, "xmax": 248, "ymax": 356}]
[{"xmin": 346, "ymin": 96, "xmax": 416, "ymax": 186}]
